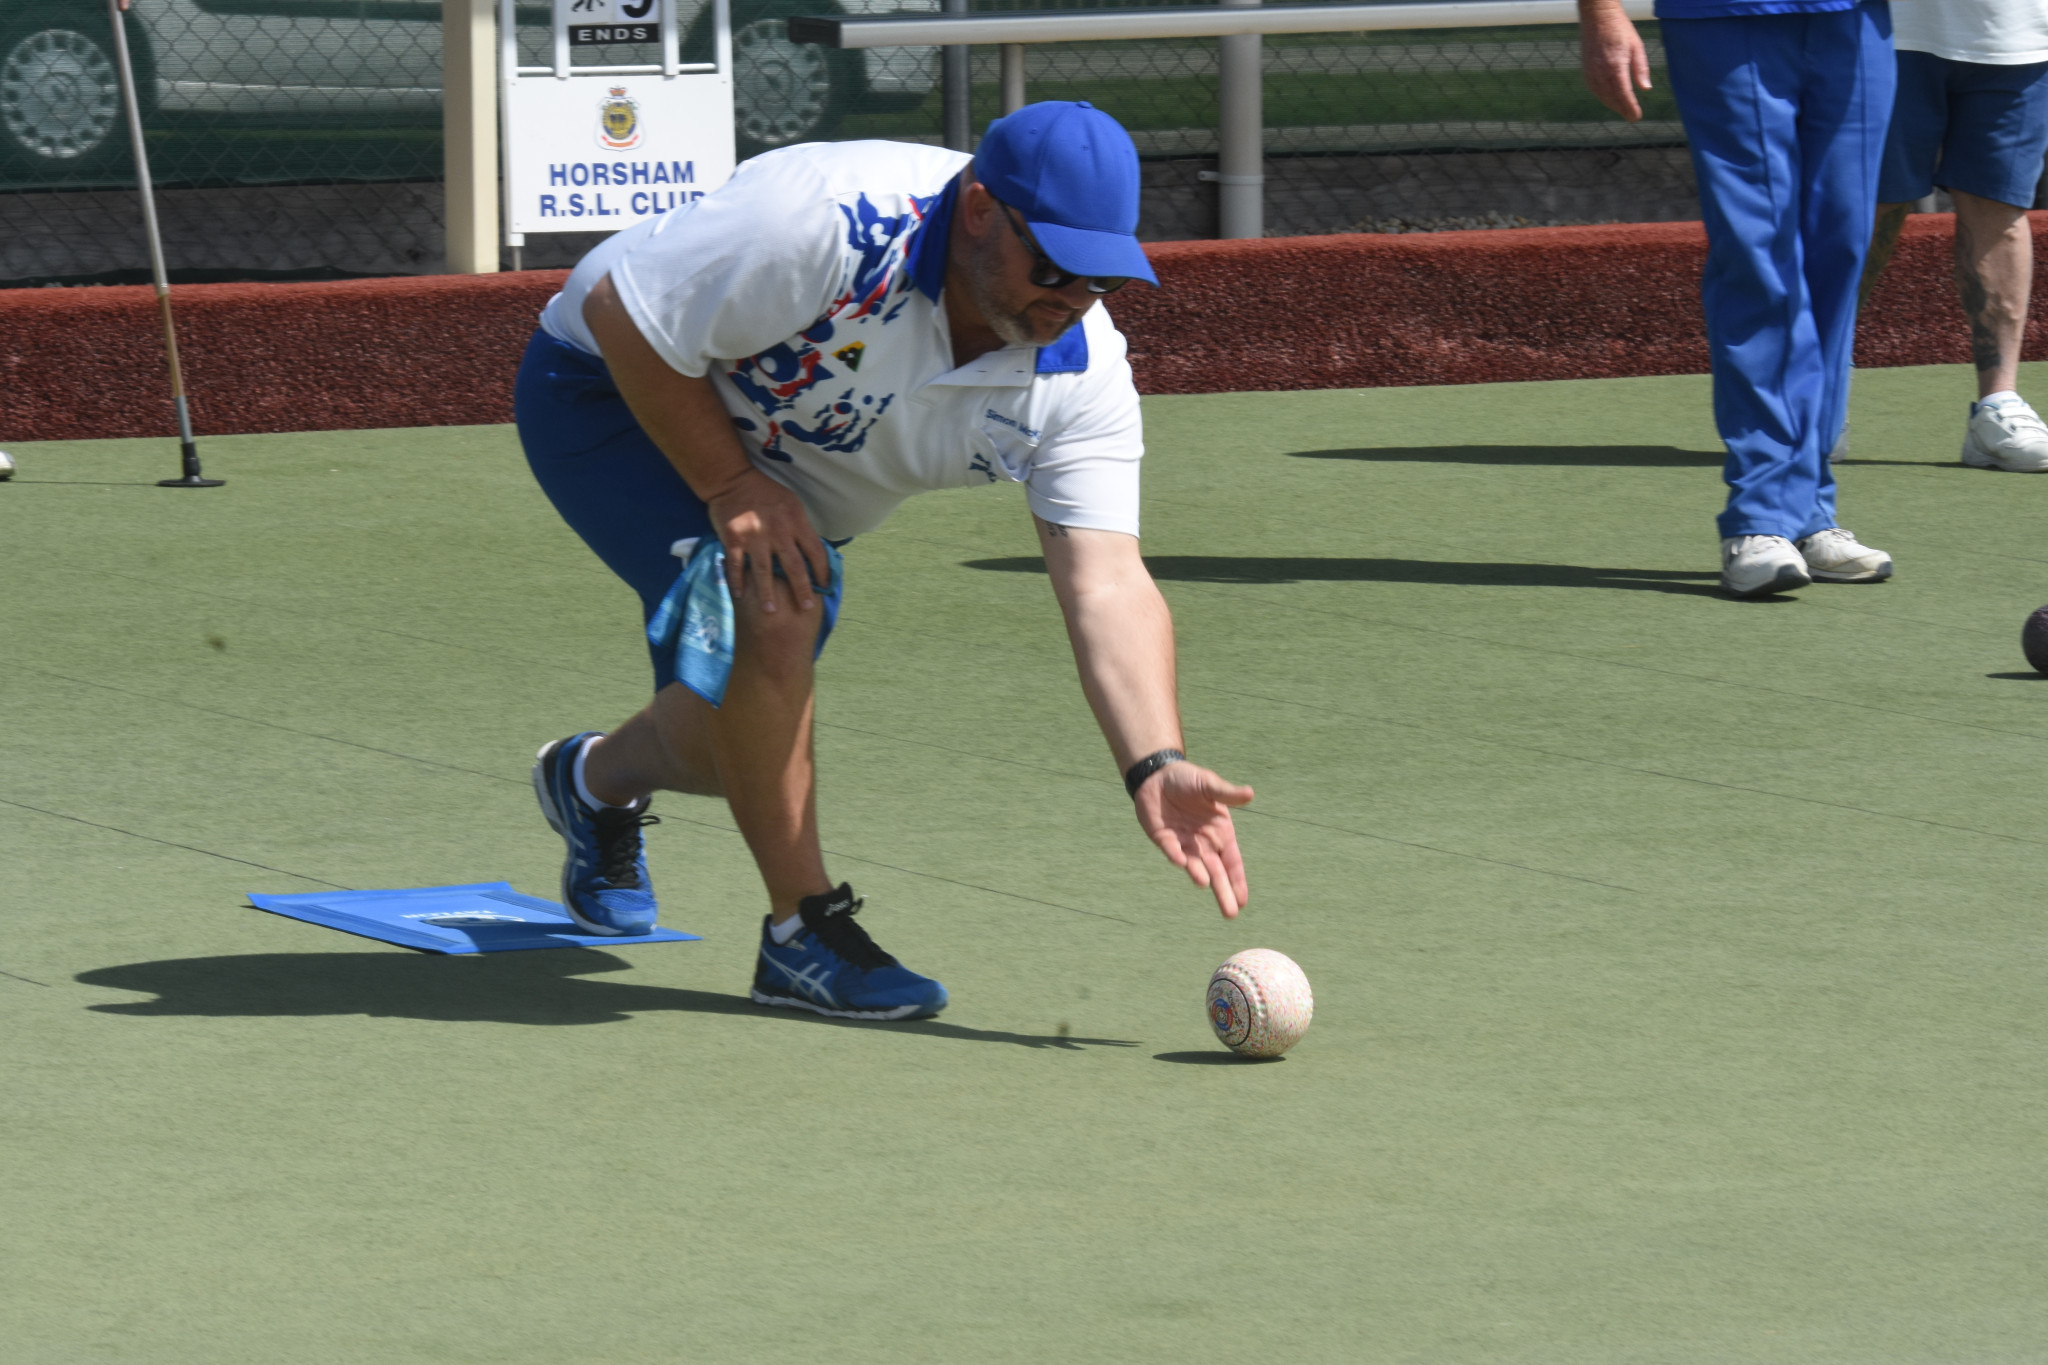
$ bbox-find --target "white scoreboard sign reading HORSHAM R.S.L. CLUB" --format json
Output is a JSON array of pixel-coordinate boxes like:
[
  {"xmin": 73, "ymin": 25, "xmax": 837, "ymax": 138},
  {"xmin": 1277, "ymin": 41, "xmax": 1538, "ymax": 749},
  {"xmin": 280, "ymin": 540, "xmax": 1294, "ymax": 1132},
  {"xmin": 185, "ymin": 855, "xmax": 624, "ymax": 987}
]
[{"xmin": 500, "ymin": 0, "xmax": 733, "ymax": 248}]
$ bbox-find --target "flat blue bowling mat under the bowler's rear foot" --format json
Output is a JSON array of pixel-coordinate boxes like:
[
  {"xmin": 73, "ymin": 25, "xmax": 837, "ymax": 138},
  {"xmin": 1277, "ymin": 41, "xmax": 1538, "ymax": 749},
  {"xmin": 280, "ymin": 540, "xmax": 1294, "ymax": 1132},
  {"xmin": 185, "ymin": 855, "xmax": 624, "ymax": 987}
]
[{"xmin": 250, "ymin": 882, "xmax": 698, "ymax": 954}]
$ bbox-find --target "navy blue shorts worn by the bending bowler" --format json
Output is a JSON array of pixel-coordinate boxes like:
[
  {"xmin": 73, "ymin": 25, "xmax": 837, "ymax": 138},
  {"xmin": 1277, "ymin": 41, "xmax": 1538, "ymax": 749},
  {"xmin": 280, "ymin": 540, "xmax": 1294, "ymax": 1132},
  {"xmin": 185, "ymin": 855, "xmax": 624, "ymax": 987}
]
[{"xmin": 512, "ymin": 332, "xmax": 711, "ymax": 692}]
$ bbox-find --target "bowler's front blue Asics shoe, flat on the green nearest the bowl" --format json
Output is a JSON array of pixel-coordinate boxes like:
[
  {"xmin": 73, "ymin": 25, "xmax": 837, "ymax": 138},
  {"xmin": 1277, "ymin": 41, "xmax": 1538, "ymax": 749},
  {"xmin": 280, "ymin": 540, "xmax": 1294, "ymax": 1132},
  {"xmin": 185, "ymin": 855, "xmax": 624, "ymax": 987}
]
[{"xmin": 754, "ymin": 882, "xmax": 946, "ymax": 1019}]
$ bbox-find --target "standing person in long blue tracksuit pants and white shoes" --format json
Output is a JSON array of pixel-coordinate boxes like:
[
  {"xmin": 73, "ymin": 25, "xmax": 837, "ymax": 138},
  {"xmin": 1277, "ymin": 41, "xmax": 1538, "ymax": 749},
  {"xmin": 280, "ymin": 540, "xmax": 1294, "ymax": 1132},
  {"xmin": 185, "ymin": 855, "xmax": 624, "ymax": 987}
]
[{"xmin": 1579, "ymin": 0, "xmax": 1896, "ymax": 598}]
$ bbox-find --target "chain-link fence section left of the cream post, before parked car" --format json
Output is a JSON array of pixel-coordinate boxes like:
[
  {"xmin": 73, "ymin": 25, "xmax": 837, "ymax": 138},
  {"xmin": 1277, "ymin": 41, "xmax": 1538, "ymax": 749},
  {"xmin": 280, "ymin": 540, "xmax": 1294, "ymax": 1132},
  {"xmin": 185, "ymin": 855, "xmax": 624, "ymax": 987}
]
[{"xmin": 0, "ymin": 0, "xmax": 442, "ymax": 282}]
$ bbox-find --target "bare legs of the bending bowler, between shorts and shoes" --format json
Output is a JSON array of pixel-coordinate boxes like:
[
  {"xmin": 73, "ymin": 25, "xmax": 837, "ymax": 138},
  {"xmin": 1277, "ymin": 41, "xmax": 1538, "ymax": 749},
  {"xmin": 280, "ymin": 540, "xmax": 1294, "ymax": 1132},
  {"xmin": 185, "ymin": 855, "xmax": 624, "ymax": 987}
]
[{"xmin": 584, "ymin": 581, "xmax": 831, "ymax": 923}]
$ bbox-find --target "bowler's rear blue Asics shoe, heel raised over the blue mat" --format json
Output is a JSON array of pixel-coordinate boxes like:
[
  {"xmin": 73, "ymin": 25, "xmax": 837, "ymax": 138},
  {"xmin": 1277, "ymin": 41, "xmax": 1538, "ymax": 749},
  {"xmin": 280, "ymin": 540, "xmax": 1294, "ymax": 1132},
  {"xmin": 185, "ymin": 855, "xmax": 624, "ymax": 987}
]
[{"xmin": 532, "ymin": 731, "xmax": 662, "ymax": 937}]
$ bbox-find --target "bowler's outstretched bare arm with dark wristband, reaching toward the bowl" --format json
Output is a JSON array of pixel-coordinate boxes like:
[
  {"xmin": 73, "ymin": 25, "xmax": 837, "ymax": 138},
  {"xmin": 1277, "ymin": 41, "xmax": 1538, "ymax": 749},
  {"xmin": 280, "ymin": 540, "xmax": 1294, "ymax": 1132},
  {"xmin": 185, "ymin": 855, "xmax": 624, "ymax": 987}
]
[{"xmin": 1032, "ymin": 518, "xmax": 1251, "ymax": 919}]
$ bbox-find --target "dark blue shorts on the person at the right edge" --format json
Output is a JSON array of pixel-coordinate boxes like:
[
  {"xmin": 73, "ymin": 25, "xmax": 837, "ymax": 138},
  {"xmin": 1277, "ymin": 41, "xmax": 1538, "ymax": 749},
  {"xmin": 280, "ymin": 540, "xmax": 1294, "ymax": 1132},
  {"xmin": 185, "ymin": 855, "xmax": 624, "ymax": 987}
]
[{"xmin": 1878, "ymin": 51, "xmax": 2048, "ymax": 209}]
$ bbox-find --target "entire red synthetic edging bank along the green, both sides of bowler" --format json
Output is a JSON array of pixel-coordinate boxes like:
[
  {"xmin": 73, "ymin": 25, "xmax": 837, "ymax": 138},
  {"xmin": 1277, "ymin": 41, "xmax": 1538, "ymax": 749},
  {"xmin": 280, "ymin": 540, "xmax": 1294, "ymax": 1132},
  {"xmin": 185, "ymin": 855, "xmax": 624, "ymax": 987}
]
[{"xmin": 0, "ymin": 213, "xmax": 2015, "ymax": 440}]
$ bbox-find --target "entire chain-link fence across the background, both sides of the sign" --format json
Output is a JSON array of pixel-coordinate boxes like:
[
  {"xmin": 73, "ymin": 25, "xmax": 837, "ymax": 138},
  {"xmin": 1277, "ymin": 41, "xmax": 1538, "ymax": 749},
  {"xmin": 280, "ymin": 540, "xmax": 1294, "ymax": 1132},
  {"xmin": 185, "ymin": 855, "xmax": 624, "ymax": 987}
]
[{"xmin": 0, "ymin": 0, "xmax": 1698, "ymax": 284}]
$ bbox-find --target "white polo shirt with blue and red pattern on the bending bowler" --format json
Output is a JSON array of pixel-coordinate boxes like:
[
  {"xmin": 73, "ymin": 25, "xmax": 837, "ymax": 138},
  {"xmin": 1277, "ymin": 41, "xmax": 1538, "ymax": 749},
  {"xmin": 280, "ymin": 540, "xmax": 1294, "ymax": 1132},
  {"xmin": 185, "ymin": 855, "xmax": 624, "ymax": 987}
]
[{"xmin": 541, "ymin": 141, "xmax": 1145, "ymax": 540}]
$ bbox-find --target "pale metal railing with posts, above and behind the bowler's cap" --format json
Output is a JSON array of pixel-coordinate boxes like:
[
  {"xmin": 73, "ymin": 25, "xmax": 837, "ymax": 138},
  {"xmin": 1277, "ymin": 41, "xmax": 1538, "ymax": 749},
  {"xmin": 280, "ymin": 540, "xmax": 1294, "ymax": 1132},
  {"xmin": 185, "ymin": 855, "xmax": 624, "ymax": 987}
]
[{"xmin": 788, "ymin": 0, "xmax": 1653, "ymax": 237}]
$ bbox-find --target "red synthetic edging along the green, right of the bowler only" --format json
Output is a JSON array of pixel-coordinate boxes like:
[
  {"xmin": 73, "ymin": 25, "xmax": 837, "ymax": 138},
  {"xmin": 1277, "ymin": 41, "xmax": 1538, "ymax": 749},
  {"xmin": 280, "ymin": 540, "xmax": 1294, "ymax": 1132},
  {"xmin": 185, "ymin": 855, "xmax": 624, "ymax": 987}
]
[{"xmin": 1114, "ymin": 213, "xmax": 2048, "ymax": 393}]
